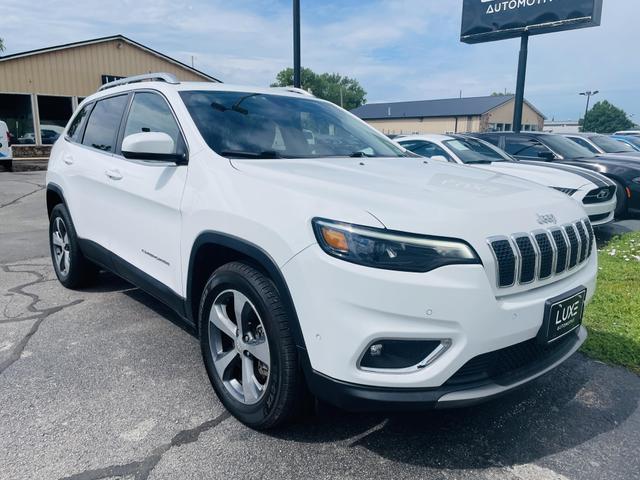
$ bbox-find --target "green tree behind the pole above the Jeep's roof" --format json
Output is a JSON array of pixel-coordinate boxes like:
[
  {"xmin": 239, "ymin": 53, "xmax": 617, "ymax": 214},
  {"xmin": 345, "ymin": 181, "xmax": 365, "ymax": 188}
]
[{"xmin": 271, "ymin": 68, "xmax": 367, "ymax": 110}]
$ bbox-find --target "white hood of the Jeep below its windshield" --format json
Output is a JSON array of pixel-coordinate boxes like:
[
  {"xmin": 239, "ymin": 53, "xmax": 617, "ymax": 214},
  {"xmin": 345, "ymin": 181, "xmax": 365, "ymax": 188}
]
[{"xmin": 231, "ymin": 157, "xmax": 586, "ymax": 240}]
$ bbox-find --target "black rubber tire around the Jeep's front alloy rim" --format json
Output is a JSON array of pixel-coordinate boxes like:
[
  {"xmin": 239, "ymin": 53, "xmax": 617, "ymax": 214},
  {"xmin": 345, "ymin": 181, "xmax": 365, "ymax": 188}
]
[{"xmin": 199, "ymin": 262, "xmax": 307, "ymax": 430}]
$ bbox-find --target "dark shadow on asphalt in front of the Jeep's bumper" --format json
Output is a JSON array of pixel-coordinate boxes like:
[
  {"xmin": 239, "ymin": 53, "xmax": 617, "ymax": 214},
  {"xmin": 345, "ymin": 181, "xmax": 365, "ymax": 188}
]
[{"xmin": 269, "ymin": 354, "xmax": 640, "ymax": 469}]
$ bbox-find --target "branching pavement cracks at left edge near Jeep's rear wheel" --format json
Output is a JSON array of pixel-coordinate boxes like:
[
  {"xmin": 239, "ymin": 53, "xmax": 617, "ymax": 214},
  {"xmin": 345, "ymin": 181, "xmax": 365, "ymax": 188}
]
[{"xmin": 0, "ymin": 265, "xmax": 84, "ymax": 375}]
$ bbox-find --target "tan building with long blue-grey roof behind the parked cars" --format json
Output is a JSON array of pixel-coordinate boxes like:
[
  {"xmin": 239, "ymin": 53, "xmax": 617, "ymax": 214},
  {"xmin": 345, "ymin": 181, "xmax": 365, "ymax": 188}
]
[{"xmin": 351, "ymin": 95, "xmax": 545, "ymax": 135}]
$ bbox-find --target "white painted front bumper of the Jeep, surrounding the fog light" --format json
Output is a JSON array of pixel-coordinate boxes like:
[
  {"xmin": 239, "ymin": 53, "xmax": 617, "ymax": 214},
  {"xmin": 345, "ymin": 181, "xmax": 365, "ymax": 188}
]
[{"xmin": 282, "ymin": 245, "xmax": 597, "ymax": 390}]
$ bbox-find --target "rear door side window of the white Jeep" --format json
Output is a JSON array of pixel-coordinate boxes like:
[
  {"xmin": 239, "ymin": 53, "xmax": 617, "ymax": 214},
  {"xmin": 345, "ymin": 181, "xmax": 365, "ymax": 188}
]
[{"xmin": 82, "ymin": 95, "xmax": 127, "ymax": 152}]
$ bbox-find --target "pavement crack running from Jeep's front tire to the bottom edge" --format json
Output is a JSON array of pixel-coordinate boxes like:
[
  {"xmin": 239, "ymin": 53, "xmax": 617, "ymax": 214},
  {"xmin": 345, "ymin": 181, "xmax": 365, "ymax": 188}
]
[{"xmin": 60, "ymin": 411, "xmax": 231, "ymax": 480}]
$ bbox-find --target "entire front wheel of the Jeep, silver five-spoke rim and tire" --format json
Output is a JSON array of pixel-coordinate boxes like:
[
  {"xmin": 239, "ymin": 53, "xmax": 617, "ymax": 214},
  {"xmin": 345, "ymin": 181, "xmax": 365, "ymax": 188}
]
[{"xmin": 199, "ymin": 262, "xmax": 308, "ymax": 429}]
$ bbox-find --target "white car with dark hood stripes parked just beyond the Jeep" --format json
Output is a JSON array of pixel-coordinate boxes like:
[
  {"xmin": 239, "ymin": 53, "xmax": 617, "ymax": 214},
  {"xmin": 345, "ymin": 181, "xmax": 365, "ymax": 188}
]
[{"xmin": 397, "ymin": 134, "xmax": 616, "ymax": 226}]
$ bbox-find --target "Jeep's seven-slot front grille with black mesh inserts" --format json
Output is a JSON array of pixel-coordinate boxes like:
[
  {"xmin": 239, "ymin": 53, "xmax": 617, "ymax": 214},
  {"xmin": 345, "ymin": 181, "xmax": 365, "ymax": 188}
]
[{"xmin": 488, "ymin": 218, "xmax": 595, "ymax": 288}]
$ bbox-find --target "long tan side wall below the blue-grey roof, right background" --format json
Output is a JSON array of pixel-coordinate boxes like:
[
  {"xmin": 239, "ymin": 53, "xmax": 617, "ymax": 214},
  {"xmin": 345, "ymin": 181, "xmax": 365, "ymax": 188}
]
[{"xmin": 367, "ymin": 116, "xmax": 480, "ymax": 135}]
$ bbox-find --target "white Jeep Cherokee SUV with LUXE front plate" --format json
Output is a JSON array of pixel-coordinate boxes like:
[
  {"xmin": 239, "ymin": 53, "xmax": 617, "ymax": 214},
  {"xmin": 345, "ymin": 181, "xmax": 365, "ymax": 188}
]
[{"xmin": 47, "ymin": 74, "xmax": 597, "ymax": 428}]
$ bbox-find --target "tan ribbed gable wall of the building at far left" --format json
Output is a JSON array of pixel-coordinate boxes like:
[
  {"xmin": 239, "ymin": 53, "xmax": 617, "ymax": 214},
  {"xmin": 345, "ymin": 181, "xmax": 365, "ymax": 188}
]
[{"xmin": 0, "ymin": 40, "xmax": 206, "ymax": 97}]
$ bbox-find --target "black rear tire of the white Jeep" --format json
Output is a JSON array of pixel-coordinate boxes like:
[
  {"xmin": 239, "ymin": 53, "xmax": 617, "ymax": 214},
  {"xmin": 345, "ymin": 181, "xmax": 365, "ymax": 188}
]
[{"xmin": 49, "ymin": 203, "xmax": 98, "ymax": 289}]
